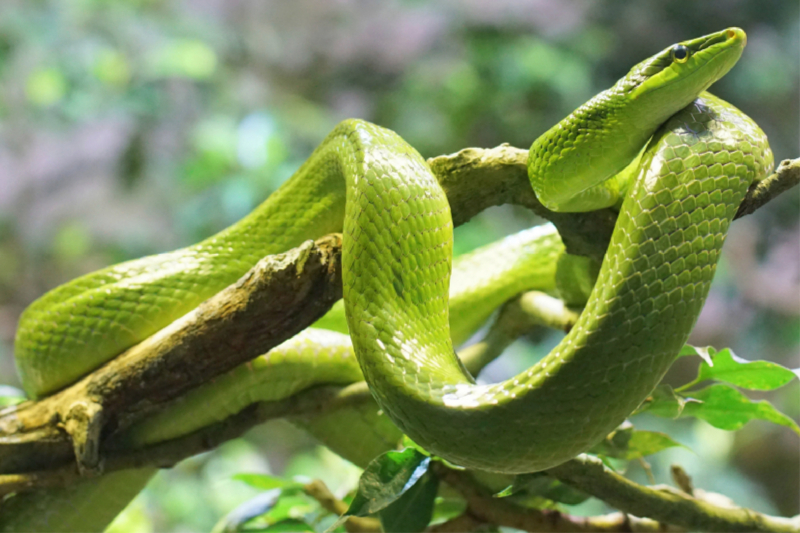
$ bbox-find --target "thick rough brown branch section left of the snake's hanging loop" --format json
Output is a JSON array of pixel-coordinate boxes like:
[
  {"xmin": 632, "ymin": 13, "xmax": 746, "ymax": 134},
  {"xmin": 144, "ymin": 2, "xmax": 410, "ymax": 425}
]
[{"xmin": 0, "ymin": 236, "xmax": 342, "ymax": 472}]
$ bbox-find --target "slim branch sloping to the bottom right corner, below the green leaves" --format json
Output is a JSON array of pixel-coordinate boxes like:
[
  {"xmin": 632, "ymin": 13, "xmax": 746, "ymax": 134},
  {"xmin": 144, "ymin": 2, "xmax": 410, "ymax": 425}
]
[{"xmin": 548, "ymin": 456, "xmax": 800, "ymax": 532}]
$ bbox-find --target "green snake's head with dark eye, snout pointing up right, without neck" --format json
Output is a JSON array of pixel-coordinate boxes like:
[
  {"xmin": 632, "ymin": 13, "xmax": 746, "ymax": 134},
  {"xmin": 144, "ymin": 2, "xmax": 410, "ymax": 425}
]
[{"xmin": 619, "ymin": 28, "xmax": 747, "ymax": 116}]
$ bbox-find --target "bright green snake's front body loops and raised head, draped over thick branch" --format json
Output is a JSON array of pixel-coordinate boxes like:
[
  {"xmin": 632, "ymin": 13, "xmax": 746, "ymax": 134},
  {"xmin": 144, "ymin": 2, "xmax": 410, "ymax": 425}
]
[{"xmin": 3, "ymin": 28, "xmax": 772, "ymax": 528}]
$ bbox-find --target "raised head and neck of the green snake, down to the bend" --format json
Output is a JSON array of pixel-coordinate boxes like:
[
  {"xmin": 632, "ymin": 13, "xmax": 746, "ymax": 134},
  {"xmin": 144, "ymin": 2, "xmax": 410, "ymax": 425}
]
[{"xmin": 528, "ymin": 28, "xmax": 747, "ymax": 212}]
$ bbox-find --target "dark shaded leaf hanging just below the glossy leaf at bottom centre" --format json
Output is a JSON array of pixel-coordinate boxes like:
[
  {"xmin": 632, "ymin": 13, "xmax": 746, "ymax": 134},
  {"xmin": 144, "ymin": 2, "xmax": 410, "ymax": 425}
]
[{"xmin": 380, "ymin": 472, "xmax": 439, "ymax": 533}]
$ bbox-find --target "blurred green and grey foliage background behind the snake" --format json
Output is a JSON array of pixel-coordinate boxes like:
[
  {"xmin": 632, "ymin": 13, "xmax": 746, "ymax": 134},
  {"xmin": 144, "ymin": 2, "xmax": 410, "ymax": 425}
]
[{"xmin": 0, "ymin": 0, "xmax": 800, "ymax": 531}]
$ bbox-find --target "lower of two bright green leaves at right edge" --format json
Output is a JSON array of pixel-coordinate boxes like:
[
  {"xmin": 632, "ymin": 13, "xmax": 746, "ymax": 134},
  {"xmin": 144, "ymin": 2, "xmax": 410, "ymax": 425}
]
[{"xmin": 682, "ymin": 384, "xmax": 800, "ymax": 435}]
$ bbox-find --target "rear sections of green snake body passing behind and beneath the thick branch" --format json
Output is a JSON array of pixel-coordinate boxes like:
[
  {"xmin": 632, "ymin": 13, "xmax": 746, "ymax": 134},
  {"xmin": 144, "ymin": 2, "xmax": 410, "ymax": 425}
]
[{"xmin": 0, "ymin": 224, "xmax": 564, "ymax": 533}]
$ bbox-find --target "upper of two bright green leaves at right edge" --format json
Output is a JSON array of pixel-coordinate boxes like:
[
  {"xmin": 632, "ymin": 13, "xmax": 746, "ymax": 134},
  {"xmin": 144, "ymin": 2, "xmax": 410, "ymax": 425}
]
[{"xmin": 681, "ymin": 347, "xmax": 797, "ymax": 390}]
